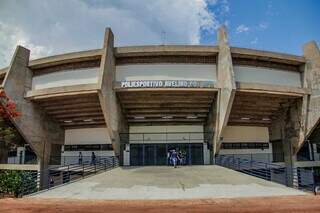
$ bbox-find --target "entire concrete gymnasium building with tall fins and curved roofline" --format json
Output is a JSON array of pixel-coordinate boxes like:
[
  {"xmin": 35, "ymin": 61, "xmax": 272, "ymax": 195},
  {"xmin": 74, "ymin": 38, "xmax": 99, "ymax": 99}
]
[{"xmin": 0, "ymin": 28, "xmax": 320, "ymax": 186}]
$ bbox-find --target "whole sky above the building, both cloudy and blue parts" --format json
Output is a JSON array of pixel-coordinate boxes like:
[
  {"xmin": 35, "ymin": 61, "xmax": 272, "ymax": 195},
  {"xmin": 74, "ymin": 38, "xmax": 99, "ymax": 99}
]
[{"xmin": 0, "ymin": 0, "xmax": 320, "ymax": 68}]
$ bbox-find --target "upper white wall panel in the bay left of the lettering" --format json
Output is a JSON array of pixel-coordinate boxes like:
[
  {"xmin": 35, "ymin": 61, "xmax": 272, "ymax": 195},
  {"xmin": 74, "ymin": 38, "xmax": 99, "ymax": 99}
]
[{"xmin": 32, "ymin": 68, "xmax": 99, "ymax": 90}]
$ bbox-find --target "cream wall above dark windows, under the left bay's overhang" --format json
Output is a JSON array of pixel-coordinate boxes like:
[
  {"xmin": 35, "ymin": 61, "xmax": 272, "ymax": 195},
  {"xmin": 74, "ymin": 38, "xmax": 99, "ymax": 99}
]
[{"xmin": 65, "ymin": 128, "xmax": 111, "ymax": 145}]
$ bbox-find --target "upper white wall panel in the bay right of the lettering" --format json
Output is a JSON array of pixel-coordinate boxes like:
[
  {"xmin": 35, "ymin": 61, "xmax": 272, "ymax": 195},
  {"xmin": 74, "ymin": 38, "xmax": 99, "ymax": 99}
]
[{"xmin": 233, "ymin": 66, "xmax": 302, "ymax": 87}]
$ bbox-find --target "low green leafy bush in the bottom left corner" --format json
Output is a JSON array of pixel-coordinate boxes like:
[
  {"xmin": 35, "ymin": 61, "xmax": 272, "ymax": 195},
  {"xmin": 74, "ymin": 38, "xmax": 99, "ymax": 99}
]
[{"xmin": 0, "ymin": 170, "xmax": 37, "ymax": 197}]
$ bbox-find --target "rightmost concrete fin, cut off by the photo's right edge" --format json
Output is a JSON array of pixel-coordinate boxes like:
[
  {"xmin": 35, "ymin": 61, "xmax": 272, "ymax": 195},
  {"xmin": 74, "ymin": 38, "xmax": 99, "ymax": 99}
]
[{"xmin": 300, "ymin": 41, "xmax": 320, "ymax": 149}]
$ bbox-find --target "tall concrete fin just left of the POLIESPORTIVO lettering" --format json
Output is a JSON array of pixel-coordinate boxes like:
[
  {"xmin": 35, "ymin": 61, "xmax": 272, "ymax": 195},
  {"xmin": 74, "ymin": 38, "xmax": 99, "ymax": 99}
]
[{"xmin": 99, "ymin": 28, "xmax": 125, "ymax": 155}]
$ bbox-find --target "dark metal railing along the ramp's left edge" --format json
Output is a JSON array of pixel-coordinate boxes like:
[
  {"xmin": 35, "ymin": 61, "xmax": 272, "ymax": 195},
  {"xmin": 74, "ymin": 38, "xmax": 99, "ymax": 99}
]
[{"xmin": 21, "ymin": 156, "xmax": 119, "ymax": 196}]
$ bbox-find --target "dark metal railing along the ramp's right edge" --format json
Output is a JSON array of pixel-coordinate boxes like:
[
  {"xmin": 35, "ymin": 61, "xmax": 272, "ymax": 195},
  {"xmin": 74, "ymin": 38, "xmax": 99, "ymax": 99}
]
[{"xmin": 215, "ymin": 155, "xmax": 316, "ymax": 191}]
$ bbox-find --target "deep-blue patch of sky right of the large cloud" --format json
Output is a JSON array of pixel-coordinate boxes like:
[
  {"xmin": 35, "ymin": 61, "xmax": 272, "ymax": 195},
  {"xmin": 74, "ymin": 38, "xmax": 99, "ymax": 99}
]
[{"xmin": 201, "ymin": 0, "xmax": 320, "ymax": 55}]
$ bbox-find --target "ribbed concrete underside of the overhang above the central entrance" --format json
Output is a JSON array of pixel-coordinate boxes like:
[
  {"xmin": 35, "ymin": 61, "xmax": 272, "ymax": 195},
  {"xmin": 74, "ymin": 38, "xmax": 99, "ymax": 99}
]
[{"xmin": 117, "ymin": 89, "xmax": 216, "ymax": 125}]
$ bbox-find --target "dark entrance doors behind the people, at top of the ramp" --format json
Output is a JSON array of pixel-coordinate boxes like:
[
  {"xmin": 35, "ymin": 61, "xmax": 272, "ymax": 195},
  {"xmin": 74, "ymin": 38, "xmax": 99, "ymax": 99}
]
[{"xmin": 130, "ymin": 143, "xmax": 204, "ymax": 166}]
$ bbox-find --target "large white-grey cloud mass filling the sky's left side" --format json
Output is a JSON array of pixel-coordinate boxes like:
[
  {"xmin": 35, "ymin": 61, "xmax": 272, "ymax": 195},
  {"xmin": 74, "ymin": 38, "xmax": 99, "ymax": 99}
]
[{"xmin": 0, "ymin": 0, "xmax": 219, "ymax": 67}]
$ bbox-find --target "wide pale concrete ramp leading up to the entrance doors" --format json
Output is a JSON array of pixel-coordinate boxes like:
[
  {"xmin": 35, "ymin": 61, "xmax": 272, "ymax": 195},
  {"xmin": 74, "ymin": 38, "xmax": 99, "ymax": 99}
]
[{"xmin": 33, "ymin": 165, "xmax": 305, "ymax": 200}]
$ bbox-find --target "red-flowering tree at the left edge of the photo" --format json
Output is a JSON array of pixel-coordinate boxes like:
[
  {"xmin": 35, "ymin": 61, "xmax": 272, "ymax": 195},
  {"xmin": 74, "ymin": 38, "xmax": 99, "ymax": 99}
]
[{"xmin": 0, "ymin": 90, "xmax": 21, "ymax": 163}]
